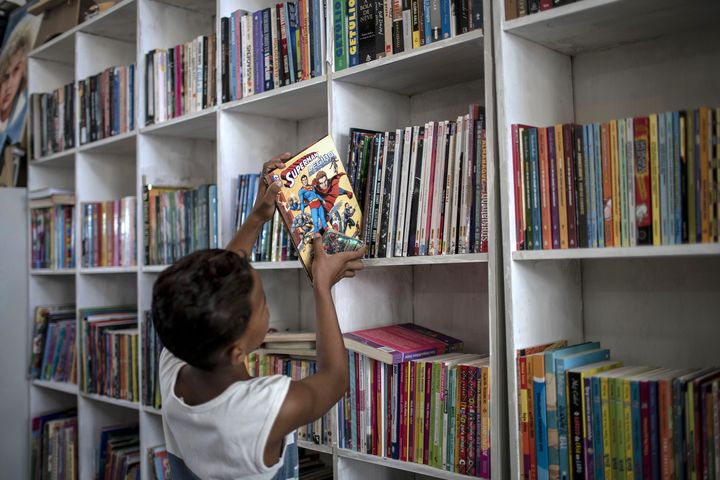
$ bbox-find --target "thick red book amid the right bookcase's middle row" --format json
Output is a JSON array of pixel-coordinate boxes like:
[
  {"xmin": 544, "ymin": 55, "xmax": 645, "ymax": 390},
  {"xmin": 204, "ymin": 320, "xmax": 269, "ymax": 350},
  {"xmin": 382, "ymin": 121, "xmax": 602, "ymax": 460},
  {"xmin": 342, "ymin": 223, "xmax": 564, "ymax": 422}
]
[{"xmin": 633, "ymin": 117, "xmax": 653, "ymax": 245}]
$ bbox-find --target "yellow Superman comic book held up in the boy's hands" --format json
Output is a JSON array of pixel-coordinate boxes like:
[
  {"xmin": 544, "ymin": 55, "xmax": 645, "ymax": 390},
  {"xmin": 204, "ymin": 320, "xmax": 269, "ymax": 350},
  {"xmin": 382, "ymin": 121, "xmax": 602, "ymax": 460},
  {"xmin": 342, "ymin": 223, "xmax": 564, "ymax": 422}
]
[{"xmin": 266, "ymin": 136, "xmax": 362, "ymax": 280}]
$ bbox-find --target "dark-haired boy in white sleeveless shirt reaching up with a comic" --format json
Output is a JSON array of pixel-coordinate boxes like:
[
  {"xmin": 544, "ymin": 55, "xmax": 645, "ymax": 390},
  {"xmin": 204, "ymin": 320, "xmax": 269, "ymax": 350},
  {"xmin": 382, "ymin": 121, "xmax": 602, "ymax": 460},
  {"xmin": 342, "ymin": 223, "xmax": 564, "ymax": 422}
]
[{"xmin": 152, "ymin": 153, "xmax": 364, "ymax": 479}]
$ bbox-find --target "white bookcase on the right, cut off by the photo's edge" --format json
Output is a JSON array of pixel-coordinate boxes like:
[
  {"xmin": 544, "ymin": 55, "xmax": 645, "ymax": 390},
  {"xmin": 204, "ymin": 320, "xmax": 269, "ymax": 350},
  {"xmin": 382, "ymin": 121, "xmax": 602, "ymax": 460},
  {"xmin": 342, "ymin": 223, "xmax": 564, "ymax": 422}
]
[{"xmin": 493, "ymin": 0, "xmax": 720, "ymax": 479}]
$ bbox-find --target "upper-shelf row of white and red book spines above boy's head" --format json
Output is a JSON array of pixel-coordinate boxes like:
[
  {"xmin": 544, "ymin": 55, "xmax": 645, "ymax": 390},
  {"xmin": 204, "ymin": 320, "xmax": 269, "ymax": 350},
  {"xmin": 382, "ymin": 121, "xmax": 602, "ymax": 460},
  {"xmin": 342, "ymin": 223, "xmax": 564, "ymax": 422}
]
[{"xmin": 145, "ymin": 35, "xmax": 217, "ymax": 125}]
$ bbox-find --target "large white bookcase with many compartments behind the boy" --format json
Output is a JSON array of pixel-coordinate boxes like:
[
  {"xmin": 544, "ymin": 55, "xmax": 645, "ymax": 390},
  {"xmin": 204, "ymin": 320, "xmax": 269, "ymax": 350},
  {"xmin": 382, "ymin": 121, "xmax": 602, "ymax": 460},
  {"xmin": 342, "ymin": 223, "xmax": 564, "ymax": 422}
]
[{"xmin": 28, "ymin": 0, "xmax": 509, "ymax": 479}]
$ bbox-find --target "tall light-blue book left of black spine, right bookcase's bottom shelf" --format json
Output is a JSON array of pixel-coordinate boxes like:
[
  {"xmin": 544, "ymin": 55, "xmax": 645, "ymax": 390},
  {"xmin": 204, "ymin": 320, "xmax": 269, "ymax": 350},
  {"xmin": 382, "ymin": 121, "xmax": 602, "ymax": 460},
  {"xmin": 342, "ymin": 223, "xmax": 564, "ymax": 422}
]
[{"xmin": 555, "ymin": 344, "xmax": 610, "ymax": 480}]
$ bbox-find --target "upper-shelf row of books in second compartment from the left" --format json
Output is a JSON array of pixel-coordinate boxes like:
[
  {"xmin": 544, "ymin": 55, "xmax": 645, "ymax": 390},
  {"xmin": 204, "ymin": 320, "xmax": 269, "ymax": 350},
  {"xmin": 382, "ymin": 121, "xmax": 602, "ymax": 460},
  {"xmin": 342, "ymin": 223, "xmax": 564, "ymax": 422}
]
[{"xmin": 78, "ymin": 64, "xmax": 135, "ymax": 145}]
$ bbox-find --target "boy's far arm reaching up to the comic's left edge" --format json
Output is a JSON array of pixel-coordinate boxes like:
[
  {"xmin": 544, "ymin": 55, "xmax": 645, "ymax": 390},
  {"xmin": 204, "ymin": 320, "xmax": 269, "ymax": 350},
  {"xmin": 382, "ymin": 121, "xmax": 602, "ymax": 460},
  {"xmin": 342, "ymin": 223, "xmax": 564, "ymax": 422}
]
[{"xmin": 225, "ymin": 156, "xmax": 292, "ymax": 256}]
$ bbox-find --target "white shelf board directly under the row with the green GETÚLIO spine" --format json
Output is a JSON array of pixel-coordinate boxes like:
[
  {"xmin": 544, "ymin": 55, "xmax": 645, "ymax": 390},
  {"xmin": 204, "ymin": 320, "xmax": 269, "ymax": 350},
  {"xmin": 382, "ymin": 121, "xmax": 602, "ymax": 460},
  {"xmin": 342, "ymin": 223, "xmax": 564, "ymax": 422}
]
[{"xmin": 332, "ymin": 30, "xmax": 484, "ymax": 95}]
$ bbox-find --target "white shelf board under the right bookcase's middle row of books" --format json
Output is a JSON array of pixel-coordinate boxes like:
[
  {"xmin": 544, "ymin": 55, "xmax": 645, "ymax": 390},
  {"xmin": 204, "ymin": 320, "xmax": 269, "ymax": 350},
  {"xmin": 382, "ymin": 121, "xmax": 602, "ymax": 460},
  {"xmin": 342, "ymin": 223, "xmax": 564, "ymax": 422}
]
[{"xmin": 512, "ymin": 243, "xmax": 720, "ymax": 260}]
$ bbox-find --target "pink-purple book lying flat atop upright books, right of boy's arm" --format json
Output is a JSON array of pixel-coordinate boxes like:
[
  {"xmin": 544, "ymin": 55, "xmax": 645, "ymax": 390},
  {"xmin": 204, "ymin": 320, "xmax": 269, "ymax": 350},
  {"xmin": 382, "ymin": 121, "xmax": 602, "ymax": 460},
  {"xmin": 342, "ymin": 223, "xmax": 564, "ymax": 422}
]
[{"xmin": 343, "ymin": 323, "xmax": 463, "ymax": 364}]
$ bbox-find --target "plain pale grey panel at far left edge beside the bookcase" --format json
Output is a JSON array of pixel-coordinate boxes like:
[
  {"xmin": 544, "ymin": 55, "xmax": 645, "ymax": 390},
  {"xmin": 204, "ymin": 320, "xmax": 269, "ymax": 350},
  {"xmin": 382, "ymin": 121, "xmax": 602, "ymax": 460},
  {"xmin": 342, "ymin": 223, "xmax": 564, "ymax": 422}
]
[{"xmin": 0, "ymin": 188, "xmax": 30, "ymax": 478}]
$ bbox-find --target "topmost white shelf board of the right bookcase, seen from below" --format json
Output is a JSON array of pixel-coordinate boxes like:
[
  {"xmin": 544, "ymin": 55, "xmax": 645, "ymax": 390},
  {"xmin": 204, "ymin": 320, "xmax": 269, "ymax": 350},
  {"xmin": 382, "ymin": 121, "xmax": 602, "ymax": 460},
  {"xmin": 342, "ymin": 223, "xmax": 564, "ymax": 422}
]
[{"xmin": 503, "ymin": 0, "xmax": 720, "ymax": 55}]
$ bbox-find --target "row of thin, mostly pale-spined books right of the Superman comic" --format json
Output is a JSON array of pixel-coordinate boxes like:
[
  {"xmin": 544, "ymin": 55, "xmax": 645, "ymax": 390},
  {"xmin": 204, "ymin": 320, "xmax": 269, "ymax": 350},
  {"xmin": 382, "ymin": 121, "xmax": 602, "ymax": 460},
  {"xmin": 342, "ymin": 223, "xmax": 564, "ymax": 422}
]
[{"xmin": 350, "ymin": 105, "xmax": 488, "ymax": 258}]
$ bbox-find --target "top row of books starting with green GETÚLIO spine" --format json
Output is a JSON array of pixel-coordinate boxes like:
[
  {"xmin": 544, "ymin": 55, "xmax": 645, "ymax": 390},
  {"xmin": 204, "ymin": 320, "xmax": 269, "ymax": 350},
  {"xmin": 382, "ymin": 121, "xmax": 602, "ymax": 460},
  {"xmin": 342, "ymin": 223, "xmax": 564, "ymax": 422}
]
[{"xmin": 333, "ymin": 0, "xmax": 483, "ymax": 72}]
